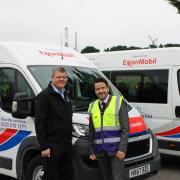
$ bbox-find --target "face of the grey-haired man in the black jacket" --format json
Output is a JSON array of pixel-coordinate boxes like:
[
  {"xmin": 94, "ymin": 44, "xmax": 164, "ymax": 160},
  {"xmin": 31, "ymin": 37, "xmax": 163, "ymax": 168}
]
[{"xmin": 52, "ymin": 71, "xmax": 68, "ymax": 89}]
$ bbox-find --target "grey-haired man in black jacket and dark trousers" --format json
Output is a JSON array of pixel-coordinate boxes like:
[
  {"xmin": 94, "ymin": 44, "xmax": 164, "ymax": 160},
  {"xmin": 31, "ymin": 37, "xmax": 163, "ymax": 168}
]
[{"xmin": 35, "ymin": 67, "xmax": 72, "ymax": 180}]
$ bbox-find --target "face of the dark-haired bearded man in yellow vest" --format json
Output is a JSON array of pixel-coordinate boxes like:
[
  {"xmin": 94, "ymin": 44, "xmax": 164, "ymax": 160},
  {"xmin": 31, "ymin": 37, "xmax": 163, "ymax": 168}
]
[{"xmin": 95, "ymin": 82, "xmax": 109, "ymax": 100}]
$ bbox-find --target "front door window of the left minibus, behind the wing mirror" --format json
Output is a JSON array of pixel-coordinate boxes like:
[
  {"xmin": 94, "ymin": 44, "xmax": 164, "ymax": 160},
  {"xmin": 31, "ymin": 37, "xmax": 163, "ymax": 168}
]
[{"xmin": 0, "ymin": 68, "xmax": 33, "ymax": 112}]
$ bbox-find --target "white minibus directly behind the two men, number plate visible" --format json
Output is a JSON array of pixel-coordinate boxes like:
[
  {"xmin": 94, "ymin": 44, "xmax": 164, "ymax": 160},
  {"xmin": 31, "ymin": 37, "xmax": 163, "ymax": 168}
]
[{"xmin": 0, "ymin": 42, "xmax": 160, "ymax": 180}]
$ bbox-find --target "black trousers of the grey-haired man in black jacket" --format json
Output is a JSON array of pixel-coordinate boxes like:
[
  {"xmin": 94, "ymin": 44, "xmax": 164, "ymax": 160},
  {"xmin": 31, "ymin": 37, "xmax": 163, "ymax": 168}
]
[{"xmin": 43, "ymin": 143, "xmax": 72, "ymax": 180}]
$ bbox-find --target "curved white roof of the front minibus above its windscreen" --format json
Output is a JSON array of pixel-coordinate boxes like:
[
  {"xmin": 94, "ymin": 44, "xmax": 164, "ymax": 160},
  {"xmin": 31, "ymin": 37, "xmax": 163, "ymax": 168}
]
[{"xmin": 0, "ymin": 42, "xmax": 95, "ymax": 67}]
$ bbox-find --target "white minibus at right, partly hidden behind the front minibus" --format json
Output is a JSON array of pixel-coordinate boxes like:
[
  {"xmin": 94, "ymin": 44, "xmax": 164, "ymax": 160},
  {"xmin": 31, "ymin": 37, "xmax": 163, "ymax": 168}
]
[{"xmin": 86, "ymin": 47, "xmax": 180, "ymax": 156}]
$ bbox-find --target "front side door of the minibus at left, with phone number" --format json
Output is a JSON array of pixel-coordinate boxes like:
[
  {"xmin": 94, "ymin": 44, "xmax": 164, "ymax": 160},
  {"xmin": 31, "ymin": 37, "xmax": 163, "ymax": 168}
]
[{"xmin": 0, "ymin": 65, "xmax": 34, "ymax": 177}]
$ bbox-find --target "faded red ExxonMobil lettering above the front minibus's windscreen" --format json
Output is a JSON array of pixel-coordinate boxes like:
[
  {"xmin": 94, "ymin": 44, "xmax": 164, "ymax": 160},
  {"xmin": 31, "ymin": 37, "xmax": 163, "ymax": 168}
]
[{"xmin": 39, "ymin": 50, "xmax": 75, "ymax": 57}]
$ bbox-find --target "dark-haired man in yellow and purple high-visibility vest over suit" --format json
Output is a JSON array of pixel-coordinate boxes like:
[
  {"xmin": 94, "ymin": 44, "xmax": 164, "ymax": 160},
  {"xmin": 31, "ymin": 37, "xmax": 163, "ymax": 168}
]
[{"xmin": 88, "ymin": 78, "xmax": 129, "ymax": 180}]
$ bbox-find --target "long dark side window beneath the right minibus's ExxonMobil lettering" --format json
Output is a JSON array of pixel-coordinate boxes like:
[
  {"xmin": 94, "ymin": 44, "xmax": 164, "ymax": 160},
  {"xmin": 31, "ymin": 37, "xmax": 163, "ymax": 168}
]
[{"xmin": 111, "ymin": 70, "xmax": 168, "ymax": 104}]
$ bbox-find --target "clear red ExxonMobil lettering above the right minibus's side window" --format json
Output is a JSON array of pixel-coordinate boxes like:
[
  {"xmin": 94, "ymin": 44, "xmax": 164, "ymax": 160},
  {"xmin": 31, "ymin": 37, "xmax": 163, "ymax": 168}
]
[{"xmin": 123, "ymin": 58, "xmax": 156, "ymax": 67}]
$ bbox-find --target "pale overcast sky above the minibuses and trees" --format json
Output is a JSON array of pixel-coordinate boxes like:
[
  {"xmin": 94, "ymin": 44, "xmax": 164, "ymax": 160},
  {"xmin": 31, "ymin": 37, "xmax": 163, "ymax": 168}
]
[{"xmin": 0, "ymin": 0, "xmax": 180, "ymax": 50}]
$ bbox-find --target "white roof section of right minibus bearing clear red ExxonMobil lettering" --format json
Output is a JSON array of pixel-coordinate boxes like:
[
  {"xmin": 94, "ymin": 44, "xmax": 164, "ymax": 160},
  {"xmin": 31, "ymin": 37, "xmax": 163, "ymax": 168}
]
[{"xmin": 85, "ymin": 47, "xmax": 180, "ymax": 70}]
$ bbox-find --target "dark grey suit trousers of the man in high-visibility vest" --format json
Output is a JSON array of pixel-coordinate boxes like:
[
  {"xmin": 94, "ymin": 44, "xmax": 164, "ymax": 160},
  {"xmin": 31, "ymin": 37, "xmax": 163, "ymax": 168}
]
[{"xmin": 97, "ymin": 153, "xmax": 124, "ymax": 180}]
